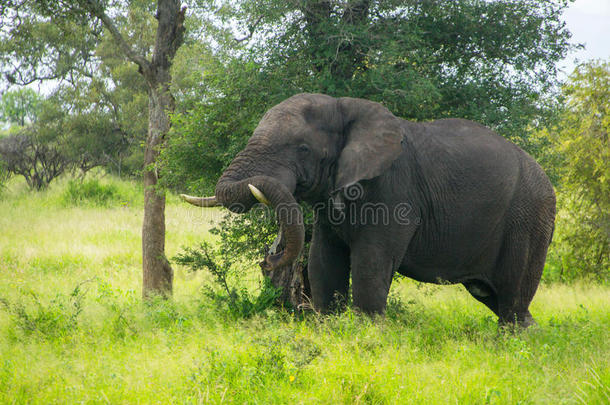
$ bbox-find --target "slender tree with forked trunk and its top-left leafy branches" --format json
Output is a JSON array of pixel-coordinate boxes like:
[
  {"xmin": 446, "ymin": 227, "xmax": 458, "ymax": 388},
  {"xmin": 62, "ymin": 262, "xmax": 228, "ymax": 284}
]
[{"xmin": 0, "ymin": 0, "xmax": 186, "ymax": 297}]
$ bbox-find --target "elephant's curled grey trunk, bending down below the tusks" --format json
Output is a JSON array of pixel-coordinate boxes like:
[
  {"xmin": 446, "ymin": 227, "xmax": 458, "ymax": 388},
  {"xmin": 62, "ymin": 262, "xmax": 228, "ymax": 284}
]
[{"xmin": 215, "ymin": 169, "xmax": 305, "ymax": 269}]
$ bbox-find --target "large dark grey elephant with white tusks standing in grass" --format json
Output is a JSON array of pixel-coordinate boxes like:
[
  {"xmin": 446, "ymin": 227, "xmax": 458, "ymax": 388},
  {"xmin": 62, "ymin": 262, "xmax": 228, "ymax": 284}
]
[{"xmin": 178, "ymin": 93, "xmax": 555, "ymax": 327}]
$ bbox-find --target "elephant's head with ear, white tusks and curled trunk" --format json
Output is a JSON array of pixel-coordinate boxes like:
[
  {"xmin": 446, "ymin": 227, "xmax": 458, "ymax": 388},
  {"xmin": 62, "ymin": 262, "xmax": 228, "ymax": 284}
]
[{"xmin": 182, "ymin": 94, "xmax": 404, "ymax": 268}]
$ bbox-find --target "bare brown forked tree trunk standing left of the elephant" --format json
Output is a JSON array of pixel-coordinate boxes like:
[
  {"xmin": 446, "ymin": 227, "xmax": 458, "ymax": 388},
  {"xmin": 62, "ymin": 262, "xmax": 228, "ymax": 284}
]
[{"xmin": 87, "ymin": 0, "xmax": 186, "ymax": 298}]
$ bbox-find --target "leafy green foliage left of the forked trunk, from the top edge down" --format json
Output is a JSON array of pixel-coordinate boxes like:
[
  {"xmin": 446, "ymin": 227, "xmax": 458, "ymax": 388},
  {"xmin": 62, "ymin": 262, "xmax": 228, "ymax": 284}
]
[{"xmin": 0, "ymin": 0, "xmax": 166, "ymax": 180}]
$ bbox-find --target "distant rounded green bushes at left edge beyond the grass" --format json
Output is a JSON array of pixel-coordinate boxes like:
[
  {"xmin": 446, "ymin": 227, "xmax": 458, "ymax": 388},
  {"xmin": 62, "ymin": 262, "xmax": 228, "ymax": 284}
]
[{"xmin": 0, "ymin": 87, "xmax": 141, "ymax": 190}]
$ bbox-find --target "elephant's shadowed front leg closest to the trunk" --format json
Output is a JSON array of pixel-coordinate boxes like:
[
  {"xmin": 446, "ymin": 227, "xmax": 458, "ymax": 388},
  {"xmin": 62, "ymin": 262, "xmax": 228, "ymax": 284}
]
[{"xmin": 307, "ymin": 224, "xmax": 349, "ymax": 312}]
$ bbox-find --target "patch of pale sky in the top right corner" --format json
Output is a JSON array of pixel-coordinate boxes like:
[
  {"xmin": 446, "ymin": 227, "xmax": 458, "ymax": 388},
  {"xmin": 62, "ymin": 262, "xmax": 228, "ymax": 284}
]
[{"xmin": 559, "ymin": 0, "xmax": 610, "ymax": 74}]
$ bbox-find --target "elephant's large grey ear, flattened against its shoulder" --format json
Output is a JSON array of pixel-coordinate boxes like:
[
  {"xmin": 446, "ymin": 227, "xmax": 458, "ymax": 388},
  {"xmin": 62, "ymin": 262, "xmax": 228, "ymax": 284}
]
[{"xmin": 335, "ymin": 97, "xmax": 404, "ymax": 191}]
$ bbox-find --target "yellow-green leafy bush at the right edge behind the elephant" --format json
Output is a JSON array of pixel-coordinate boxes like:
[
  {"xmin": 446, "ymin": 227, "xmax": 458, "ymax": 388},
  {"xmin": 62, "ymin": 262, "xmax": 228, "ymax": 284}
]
[{"xmin": 546, "ymin": 61, "xmax": 610, "ymax": 282}]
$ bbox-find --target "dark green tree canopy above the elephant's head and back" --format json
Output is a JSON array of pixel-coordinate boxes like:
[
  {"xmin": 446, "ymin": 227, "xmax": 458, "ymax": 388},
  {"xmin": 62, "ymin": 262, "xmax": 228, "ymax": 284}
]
[{"xmin": 241, "ymin": 0, "xmax": 570, "ymax": 131}]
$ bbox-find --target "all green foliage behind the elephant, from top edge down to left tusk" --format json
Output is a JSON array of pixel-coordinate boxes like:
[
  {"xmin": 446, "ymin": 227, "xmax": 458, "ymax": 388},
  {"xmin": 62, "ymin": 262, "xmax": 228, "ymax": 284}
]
[{"xmin": 165, "ymin": 0, "xmax": 572, "ymax": 193}]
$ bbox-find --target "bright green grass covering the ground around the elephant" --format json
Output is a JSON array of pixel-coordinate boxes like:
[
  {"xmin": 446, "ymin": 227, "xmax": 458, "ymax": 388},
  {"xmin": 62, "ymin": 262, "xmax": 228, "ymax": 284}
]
[{"xmin": 0, "ymin": 175, "xmax": 610, "ymax": 404}]
